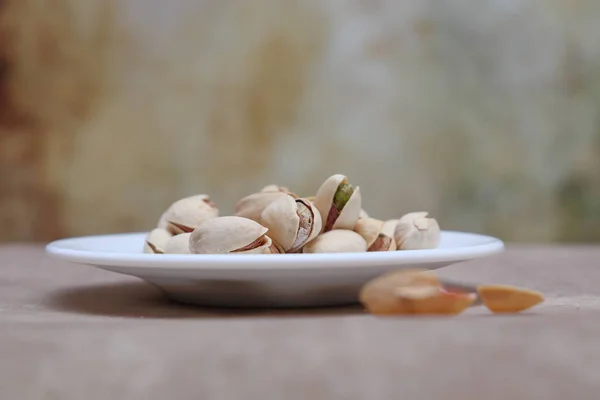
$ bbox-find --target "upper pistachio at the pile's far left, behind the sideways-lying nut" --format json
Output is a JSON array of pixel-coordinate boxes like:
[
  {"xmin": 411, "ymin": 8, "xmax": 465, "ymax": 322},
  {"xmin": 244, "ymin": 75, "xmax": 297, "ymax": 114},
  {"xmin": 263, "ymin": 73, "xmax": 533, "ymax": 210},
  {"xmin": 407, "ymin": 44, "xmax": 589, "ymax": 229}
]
[{"xmin": 158, "ymin": 194, "xmax": 219, "ymax": 235}]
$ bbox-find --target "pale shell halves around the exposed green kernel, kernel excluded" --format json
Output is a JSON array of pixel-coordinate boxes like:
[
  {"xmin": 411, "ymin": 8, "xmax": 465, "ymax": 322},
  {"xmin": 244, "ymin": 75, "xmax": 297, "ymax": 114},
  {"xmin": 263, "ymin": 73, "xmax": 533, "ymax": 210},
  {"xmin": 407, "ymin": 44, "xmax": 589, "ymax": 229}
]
[{"xmin": 314, "ymin": 174, "xmax": 362, "ymax": 231}]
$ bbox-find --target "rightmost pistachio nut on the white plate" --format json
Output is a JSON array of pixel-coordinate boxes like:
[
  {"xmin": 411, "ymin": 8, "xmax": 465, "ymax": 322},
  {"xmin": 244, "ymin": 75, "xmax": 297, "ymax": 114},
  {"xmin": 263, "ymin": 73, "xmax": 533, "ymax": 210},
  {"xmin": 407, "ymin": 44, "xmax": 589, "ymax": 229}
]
[{"xmin": 394, "ymin": 212, "xmax": 440, "ymax": 250}]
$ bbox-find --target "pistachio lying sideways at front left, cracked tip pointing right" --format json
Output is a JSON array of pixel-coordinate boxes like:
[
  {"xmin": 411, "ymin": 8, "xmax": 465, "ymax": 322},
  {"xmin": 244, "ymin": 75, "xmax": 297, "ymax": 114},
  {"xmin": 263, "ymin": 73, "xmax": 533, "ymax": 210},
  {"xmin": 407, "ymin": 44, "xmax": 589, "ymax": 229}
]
[{"xmin": 190, "ymin": 217, "xmax": 271, "ymax": 254}]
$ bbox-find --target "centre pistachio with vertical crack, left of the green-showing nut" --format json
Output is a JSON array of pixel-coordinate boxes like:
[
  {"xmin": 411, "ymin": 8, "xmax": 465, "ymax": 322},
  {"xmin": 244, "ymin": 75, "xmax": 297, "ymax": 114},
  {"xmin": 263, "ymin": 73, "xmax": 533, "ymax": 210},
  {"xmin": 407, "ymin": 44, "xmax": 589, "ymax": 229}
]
[{"xmin": 261, "ymin": 196, "xmax": 322, "ymax": 253}]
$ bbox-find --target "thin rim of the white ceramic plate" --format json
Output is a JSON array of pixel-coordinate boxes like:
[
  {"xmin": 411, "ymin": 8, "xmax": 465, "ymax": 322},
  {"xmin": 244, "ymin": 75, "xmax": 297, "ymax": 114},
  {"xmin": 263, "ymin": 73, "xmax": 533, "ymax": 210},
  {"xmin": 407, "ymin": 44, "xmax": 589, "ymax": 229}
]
[{"xmin": 45, "ymin": 230, "xmax": 505, "ymax": 270}]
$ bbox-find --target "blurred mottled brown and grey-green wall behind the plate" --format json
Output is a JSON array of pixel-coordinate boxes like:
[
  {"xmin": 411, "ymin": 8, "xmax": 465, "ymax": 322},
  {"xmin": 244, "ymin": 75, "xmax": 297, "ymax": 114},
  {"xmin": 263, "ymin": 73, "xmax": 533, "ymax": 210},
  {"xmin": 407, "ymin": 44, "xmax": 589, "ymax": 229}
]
[{"xmin": 0, "ymin": 0, "xmax": 600, "ymax": 242}]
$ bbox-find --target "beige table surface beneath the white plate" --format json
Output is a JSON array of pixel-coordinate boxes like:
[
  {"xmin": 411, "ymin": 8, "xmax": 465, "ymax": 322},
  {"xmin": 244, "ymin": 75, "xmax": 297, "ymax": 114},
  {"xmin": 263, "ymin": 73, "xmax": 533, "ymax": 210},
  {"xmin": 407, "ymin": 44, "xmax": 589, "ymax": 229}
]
[{"xmin": 0, "ymin": 245, "xmax": 600, "ymax": 400}]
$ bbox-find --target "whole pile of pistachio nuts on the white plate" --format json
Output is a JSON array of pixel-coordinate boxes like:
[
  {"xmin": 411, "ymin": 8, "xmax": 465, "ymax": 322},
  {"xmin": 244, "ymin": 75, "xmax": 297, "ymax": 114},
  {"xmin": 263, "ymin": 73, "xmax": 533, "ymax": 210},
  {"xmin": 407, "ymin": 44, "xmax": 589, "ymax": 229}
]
[{"xmin": 144, "ymin": 174, "xmax": 440, "ymax": 254}]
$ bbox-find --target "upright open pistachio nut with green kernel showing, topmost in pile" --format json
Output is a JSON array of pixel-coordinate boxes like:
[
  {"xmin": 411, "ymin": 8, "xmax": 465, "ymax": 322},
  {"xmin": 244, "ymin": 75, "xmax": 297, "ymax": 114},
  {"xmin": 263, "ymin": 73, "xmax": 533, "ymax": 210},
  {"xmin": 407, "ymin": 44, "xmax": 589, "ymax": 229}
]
[{"xmin": 315, "ymin": 174, "xmax": 361, "ymax": 232}]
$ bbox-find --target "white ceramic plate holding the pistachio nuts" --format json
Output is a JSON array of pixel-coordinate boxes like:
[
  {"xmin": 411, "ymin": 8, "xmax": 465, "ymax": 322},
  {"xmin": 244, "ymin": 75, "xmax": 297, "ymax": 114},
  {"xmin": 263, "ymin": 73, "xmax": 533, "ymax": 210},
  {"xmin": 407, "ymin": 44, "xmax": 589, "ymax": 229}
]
[{"xmin": 46, "ymin": 231, "xmax": 504, "ymax": 307}]
